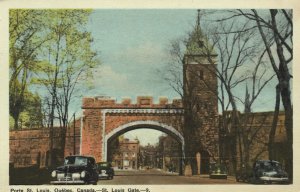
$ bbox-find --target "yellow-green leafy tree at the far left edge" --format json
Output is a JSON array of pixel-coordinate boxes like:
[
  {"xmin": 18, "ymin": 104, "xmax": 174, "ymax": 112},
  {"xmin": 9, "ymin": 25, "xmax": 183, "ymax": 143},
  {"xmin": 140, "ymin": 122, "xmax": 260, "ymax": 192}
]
[{"xmin": 9, "ymin": 9, "xmax": 48, "ymax": 129}]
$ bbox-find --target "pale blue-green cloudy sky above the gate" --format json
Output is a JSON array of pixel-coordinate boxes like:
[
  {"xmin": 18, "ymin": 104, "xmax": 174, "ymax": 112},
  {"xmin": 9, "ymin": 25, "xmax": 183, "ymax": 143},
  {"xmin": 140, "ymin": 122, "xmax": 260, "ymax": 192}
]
[{"xmin": 65, "ymin": 9, "xmax": 284, "ymax": 144}]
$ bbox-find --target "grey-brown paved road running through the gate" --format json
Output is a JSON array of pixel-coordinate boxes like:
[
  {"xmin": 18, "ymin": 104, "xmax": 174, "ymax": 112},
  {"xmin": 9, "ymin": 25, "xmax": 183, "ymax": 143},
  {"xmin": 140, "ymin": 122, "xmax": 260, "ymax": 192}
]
[{"xmin": 98, "ymin": 169, "xmax": 241, "ymax": 185}]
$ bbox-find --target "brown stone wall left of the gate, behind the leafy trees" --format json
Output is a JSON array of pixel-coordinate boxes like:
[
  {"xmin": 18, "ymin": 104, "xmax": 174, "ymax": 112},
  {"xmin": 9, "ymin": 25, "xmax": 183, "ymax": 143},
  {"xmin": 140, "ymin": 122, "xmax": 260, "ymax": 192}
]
[{"xmin": 9, "ymin": 119, "xmax": 80, "ymax": 168}]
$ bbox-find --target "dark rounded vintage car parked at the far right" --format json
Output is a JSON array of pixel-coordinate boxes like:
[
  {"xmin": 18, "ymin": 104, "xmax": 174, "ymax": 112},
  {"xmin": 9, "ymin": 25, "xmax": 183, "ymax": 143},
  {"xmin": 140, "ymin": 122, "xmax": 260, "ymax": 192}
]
[{"xmin": 253, "ymin": 160, "xmax": 289, "ymax": 183}]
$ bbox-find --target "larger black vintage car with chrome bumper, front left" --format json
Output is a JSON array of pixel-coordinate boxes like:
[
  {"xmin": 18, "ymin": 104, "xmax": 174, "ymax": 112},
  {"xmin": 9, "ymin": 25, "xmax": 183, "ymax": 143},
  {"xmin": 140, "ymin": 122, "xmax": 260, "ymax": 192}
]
[{"xmin": 51, "ymin": 155, "xmax": 98, "ymax": 184}]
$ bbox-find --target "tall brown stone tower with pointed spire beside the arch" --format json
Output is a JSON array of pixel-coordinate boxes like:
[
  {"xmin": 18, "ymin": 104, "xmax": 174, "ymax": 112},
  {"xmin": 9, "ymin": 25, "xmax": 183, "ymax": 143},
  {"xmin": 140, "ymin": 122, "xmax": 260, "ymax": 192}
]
[{"xmin": 183, "ymin": 11, "xmax": 219, "ymax": 174}]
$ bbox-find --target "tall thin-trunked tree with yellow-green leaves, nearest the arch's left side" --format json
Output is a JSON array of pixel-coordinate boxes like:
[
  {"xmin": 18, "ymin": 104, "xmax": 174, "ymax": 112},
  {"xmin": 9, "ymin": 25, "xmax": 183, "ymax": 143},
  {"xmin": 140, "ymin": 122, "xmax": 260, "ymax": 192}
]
[{"xmin": 34, "ymin": 9, "xmax": 99, "ymax": 165}]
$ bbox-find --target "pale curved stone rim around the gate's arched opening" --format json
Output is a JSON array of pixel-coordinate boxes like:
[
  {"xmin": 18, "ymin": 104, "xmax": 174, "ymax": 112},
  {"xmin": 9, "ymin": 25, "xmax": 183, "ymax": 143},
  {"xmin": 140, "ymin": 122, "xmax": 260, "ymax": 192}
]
[{"xmin": 102, "ymin": 121, "xmax": 185, "ymax": 172}]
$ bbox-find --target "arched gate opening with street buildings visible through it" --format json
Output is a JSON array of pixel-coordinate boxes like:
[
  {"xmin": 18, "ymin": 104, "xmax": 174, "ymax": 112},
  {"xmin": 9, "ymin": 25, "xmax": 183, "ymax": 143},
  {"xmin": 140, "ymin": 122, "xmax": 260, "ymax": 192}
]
[{"xmin": 106, "ymin": 122, "xmax": 184, "ymax": 174}]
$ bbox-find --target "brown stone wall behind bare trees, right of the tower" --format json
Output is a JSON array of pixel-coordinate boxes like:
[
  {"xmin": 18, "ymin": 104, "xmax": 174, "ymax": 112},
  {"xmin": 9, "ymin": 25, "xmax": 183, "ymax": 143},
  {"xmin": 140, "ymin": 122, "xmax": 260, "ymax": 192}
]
[{"xmin": 221, "ymin": 111, "xmax": 286, "ymax": 171}]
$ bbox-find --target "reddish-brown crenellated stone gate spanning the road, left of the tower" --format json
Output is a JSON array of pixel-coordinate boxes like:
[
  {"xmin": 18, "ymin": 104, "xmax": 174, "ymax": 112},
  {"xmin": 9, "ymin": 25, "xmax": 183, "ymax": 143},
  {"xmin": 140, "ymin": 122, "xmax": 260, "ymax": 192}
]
[{"xmin": 80, "ymin": 96, "xmax": 185, "ymax": 166}]
